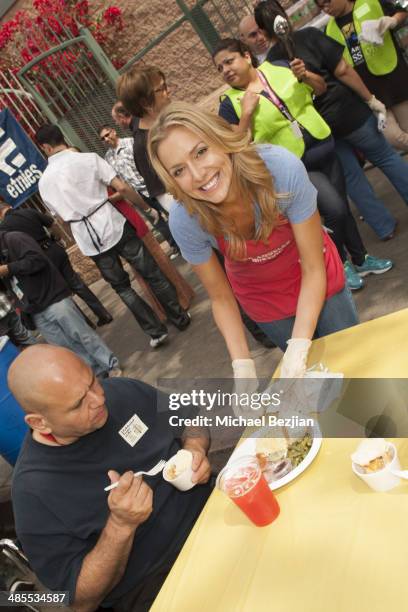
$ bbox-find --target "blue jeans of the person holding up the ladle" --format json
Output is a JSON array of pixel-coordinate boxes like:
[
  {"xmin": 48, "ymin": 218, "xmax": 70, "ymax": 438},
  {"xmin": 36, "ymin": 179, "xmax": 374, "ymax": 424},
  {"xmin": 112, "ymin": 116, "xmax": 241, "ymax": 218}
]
[{"xmin": 336, "ymin": 115, "xmax": 408, "ymax": 238}]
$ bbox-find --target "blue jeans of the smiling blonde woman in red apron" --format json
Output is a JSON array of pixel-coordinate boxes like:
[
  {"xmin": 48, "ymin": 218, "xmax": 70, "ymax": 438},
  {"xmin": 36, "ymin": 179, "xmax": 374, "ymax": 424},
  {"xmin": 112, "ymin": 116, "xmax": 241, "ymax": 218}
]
[{"xmin": 257, "ymin": 287, "xmax": 359, "ymax": 351}]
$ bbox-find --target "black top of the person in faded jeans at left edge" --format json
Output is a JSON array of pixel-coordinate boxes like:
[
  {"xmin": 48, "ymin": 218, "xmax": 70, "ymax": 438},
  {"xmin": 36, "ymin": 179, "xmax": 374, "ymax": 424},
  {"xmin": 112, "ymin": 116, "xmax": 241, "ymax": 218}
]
[{"xmin": 0, "ymin": 232, "xmax": 71, "ymax": 314}]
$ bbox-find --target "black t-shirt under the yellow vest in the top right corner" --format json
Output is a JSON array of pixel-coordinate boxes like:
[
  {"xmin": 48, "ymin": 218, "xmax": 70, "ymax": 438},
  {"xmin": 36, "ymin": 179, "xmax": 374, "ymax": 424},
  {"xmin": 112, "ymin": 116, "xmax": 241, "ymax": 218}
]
[{"xmin": 336, "ymin": 0, "xmax": 408, "ymax": 106}]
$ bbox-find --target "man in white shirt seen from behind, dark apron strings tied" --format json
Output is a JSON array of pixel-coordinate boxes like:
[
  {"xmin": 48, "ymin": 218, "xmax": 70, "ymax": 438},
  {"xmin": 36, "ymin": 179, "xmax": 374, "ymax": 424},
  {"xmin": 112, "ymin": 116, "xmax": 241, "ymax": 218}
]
[{"xmin": 36, "ymin": 125, "xmax": 190, "ymax": 348}]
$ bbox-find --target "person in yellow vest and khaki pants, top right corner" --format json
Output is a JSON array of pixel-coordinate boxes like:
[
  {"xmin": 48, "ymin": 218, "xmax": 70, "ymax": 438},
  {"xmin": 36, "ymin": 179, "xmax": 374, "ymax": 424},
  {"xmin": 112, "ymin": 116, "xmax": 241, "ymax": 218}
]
[{"xmin": 322, "ymin": 0, "xmax": 408, "ymax": 151}]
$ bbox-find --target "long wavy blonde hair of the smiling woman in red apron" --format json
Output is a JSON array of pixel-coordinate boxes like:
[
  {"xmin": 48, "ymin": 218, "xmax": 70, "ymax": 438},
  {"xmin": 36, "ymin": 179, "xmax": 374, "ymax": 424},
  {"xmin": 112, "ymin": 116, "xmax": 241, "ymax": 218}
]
[{"xmin": 148, "ymin": 102, "xmax": 279, "ymax": 259}]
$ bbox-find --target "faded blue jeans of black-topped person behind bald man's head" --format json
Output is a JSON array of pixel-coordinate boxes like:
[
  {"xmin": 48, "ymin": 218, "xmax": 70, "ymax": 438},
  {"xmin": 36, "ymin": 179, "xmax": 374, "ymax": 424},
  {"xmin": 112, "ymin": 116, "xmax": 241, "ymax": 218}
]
[{"xmin": 32, "ymin": 298, "xmax": 119, "ymax": 376}]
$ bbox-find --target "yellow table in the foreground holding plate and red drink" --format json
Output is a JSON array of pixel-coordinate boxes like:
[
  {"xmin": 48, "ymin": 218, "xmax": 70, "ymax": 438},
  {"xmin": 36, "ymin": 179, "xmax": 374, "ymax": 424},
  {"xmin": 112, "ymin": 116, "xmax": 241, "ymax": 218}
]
[{"xmin": 152, "ymin": 309, "xmax": 408, "ymax": 612}]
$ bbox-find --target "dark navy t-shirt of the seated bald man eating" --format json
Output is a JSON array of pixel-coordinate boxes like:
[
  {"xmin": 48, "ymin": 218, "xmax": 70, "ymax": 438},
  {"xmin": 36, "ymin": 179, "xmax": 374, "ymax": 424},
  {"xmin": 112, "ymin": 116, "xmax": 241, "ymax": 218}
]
[{"xmin": 12, "ymin": 378, "xmax": 210, "ymax": 605}]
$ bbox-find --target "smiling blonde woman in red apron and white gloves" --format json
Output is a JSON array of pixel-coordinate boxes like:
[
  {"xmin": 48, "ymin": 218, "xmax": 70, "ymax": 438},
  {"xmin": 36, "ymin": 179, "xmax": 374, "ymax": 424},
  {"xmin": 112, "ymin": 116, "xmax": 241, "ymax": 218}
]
[{"xmin": 148, "ymin": 102, "xmax": 358, "ymax": 378}]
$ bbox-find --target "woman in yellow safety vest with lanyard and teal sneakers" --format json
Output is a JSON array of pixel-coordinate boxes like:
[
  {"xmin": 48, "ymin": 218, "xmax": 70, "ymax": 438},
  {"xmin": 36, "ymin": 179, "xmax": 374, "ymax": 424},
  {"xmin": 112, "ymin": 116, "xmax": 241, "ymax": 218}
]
[{"xmin": 213, "ymin": 38, "xmax": 392, "ymax": 290}]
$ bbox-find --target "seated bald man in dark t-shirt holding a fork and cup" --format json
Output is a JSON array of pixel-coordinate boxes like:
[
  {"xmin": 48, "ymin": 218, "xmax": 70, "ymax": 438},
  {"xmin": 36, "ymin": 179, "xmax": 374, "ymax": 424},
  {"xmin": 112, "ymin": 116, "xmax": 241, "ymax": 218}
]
[{"xmin": 8, "ymin": 345, "xmax": 210, "ymax": 612}]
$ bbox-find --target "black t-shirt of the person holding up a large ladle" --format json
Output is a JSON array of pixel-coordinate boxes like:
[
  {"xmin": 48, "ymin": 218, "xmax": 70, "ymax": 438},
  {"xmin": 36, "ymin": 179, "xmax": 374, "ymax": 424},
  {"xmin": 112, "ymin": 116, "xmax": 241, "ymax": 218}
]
[{"xmin": 267, "ymin": 28, "xmax": 371, "ymax": 138}]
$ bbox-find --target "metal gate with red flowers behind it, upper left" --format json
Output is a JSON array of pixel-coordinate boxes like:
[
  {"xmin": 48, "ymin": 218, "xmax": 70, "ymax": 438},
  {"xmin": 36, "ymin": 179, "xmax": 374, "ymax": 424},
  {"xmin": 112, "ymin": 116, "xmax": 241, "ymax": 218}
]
[{"xmin": 18, "ymin": 20, "xmax": 118, "ymax": 154}]
